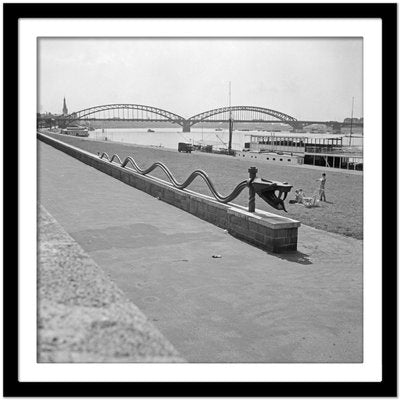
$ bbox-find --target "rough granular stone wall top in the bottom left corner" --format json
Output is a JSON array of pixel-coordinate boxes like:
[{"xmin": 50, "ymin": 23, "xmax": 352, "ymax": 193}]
[{"xmin": 37, "ymin": 206, "xmax": 185, "ymax": 363}]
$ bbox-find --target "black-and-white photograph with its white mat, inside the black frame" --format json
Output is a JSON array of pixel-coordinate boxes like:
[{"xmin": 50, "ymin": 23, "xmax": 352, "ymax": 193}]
[{"xmin": 5, "ymin": 3, "xmax": 396, "ymax": 396}]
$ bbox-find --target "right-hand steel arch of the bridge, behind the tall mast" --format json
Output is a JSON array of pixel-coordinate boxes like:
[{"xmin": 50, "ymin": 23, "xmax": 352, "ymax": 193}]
[{"xmin": 187, "ymin": 106, "xmax": 297, "ymax": 126}]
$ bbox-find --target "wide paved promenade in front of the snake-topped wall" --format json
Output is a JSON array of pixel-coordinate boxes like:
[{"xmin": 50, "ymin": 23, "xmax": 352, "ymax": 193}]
[{"xmin": 38, "ymin": 142, "xmax": 362, "ymax": 363}]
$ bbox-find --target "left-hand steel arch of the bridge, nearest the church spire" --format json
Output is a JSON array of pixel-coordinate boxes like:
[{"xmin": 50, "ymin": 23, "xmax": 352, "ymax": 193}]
[{"xmin": 64, "ymin": 104, "xmax": 186, "ymax": 126}]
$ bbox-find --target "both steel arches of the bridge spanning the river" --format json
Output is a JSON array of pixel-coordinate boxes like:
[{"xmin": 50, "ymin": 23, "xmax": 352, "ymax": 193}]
[{"xmin": 58, "ymin": 104, "xmax": 297, "ymax": 132}]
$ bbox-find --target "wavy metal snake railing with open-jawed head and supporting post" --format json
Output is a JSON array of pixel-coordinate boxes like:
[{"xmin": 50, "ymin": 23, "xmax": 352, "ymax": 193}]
[{"xmin": 97, "ymin": 152, "xmax": 292, "ymax": 212}]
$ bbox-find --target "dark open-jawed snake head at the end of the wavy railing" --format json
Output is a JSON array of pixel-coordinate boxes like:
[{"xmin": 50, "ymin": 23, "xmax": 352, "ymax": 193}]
[{"xmin": 249, "ymin": 178, "xmax": 292, "ymax": 212}]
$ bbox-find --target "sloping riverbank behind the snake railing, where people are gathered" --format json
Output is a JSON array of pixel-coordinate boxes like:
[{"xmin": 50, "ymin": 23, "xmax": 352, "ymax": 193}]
[{"xmin": 40, "ymin": 134, "xmax": 363, "ymax": 239}]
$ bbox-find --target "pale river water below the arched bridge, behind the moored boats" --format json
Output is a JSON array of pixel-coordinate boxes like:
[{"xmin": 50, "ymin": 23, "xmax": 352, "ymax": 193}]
[{"xmin": 89, "ymin": 128, "xmax": 363, "ymax": 150}]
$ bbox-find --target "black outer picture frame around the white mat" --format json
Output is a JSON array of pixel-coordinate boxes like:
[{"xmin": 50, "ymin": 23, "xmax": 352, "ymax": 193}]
[{"xmin": 3, "ymin": 3, "xmax": 397, "ymax": 397}]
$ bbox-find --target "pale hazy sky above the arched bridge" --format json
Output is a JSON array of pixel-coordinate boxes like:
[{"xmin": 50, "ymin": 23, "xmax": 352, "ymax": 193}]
[{"xmin": 38, "ymin": 38, "xmax": 363, "ymax": 121}]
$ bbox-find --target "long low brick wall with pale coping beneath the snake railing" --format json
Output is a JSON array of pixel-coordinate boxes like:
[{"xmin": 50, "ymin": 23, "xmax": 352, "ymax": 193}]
[{"xmin": 38, "ymin": 133, "xmax": 300, "ymax": 253}]
